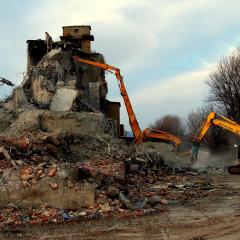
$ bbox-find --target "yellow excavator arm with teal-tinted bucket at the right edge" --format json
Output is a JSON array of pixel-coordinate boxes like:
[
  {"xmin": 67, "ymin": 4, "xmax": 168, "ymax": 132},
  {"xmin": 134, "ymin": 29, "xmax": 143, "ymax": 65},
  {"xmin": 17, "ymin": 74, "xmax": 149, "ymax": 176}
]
[{"xmin": 192, "ymin": 112, "xmax": 240, "ymax": 162}]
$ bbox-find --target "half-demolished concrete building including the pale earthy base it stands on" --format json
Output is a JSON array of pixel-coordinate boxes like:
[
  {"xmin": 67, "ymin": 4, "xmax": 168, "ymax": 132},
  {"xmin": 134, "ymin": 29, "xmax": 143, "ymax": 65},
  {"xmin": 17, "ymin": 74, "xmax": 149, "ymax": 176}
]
[{"xmin": 0, "ymin": 26, "xmax": 117, "ymax": 144}]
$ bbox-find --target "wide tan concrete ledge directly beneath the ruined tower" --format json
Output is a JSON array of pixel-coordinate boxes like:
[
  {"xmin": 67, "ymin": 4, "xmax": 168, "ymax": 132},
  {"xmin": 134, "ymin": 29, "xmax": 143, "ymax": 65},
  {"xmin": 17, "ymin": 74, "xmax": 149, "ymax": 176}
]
[{"xmin": 0, "ymin": 110, "xmax": 118, "ymax": 136}]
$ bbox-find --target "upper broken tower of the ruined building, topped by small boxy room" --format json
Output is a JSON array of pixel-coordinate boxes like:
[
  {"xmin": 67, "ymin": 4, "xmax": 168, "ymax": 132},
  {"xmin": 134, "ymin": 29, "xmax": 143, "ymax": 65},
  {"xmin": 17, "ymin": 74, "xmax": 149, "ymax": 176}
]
[{"xmin": 23, "ymin": 26, "xmax": 107, "ymax": 111}]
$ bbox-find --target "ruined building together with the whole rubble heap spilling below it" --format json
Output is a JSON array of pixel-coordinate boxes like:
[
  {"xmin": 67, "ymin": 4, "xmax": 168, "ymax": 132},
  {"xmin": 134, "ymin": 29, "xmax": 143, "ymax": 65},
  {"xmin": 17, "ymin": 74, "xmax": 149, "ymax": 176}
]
[{"xmin": 0, "ymin": 26, "xmax": 211, "ymax": 227}]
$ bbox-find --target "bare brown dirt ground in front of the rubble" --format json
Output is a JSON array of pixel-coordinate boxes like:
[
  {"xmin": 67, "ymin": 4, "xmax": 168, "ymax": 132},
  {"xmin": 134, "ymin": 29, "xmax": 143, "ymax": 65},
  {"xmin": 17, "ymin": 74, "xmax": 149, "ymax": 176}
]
[{"xmin": 1, "ymin": 175, "xmax": 240, "ymax": 240}]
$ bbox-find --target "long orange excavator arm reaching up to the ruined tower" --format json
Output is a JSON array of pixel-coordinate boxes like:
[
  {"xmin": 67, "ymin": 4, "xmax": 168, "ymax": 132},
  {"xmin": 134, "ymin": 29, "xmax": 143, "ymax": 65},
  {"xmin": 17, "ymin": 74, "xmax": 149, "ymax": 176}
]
[{"xmin": 73, "ymin": 56, "xmax": 186, "ymax": 148}]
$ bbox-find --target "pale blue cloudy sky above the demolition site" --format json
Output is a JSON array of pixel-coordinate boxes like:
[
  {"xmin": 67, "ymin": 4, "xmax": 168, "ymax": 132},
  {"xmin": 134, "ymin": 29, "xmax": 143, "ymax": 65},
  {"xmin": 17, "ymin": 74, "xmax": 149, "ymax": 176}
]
[{"xmin": 0, "ymin": 0, "xmax": 240, "ymax": 128}]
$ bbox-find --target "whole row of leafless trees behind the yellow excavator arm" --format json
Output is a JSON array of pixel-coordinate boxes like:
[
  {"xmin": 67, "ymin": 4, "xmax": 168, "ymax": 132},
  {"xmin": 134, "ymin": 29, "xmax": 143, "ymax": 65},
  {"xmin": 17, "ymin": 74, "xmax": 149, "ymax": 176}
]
[{"xmin": 150, "ymin": 49, "xmax": 240, "ymax": 152}]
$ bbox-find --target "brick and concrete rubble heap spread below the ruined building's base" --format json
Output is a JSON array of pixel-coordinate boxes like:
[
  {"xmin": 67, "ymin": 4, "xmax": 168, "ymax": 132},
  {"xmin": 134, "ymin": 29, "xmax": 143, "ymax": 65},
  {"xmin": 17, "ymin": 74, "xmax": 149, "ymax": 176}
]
[{"xmin": 0, "ymin": 127, "xmax": 211, "ymax": 226}]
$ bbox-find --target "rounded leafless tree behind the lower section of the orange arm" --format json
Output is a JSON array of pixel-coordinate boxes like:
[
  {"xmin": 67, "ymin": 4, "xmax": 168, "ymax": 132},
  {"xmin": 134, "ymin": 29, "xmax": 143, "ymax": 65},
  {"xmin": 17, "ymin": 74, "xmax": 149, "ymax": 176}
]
[{"xmin": 150, "ymin": 115, "xmax": 185, "ymax": 138}]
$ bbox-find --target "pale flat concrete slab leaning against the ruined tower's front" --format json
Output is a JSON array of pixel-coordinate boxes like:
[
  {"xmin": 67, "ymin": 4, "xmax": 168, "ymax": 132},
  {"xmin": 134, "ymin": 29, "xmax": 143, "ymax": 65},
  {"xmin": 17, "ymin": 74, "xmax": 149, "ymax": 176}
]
[{"xmin": 50, "ymin": 88, "xmax": 79, "ymax": 111}]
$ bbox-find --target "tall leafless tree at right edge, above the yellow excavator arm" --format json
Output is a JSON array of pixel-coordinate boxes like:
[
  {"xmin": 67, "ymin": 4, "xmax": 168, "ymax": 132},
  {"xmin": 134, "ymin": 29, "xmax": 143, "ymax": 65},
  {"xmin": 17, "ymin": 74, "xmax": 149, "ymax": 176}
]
[{"xmin": 206, "ymin": 49, "xmax": 240, "ymax": 122}]
